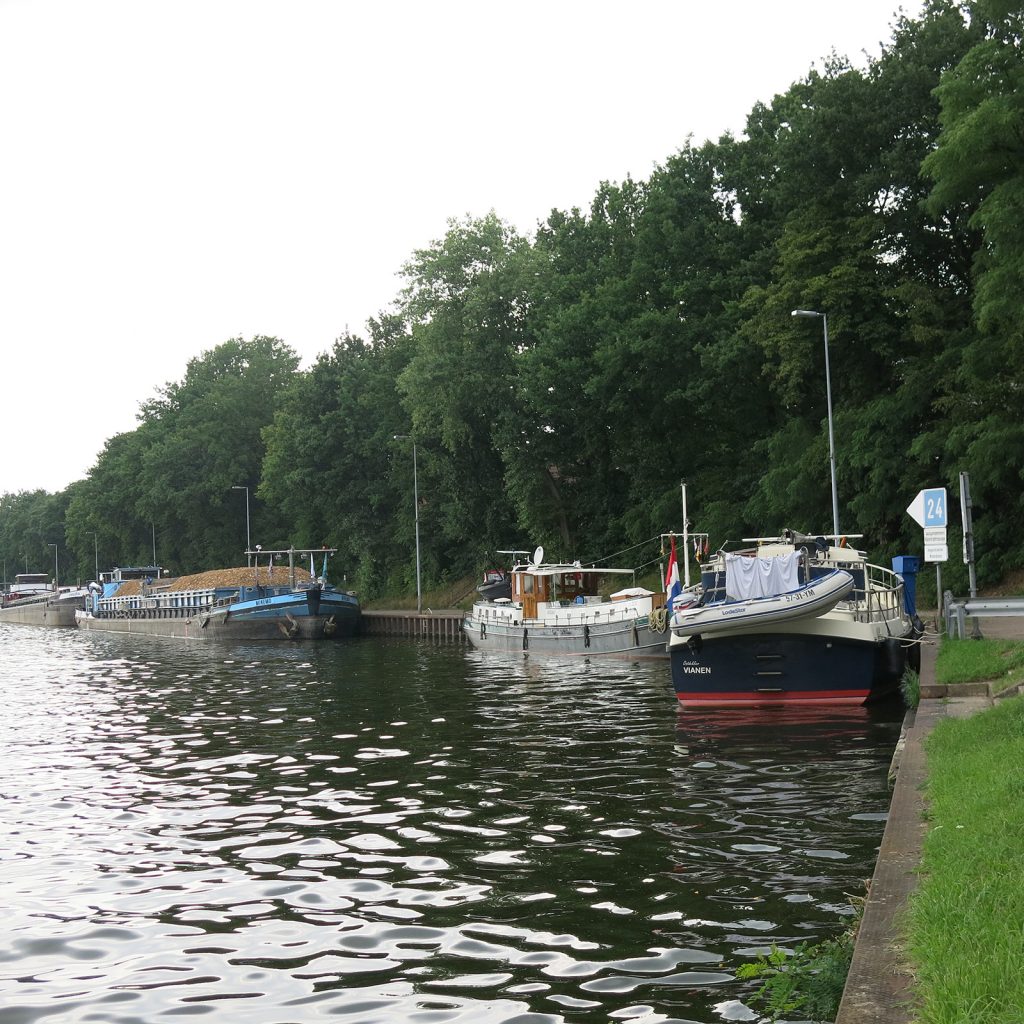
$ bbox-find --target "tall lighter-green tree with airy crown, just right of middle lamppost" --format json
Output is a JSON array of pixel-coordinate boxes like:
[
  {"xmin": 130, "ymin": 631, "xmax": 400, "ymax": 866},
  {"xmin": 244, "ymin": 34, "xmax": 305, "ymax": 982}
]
[{"xmin": 397, "ymin": 213, "xmax": 532, "ymax": 571}]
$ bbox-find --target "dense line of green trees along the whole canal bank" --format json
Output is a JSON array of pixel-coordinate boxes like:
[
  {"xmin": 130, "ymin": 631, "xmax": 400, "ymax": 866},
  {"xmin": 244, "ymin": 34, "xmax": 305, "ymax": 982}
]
[{"xmin": 0, "ymin": 0, "xmax": 1024, "ymax": 595}]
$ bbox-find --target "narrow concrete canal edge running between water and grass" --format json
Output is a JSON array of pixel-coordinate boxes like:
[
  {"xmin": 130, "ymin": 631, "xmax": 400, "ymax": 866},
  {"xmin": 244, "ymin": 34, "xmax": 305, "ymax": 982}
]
[{"xmin": 836, "ymin": 618, "xmax": 1024, "ymax": 1024}]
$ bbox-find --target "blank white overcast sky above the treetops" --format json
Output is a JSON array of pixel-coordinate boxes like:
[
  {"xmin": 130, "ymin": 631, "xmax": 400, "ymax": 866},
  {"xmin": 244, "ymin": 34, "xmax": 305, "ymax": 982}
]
[{"xmin": 0, "ymin": 0, "xmax": 922, "ymax": 494}]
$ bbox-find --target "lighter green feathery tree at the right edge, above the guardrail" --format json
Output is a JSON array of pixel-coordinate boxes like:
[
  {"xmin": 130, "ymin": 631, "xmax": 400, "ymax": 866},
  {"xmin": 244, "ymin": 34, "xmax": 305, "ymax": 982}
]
[{"xmin": 924, "ymin": 0, "xmax": 1024, "ymax": 579}]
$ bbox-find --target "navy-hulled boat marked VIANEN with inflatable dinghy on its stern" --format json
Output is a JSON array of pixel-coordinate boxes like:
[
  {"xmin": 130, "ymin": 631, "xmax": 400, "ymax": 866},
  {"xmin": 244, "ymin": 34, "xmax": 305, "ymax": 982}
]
[{"xmin": 668, "ymin": 530, "xmax": 920, "ymax": 707}]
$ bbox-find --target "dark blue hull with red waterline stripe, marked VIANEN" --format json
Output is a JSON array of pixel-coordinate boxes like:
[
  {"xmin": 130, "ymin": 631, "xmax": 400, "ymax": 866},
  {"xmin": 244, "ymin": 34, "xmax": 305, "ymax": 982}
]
[{"xmin": 670, "ymin": 633, "xmax": 907, "ymax": 707}]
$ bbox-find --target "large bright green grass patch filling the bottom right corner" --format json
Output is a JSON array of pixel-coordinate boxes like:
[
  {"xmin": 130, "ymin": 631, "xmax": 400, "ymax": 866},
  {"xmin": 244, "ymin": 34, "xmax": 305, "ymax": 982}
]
[{"xmin": 906, "ymin": 700, "xmax": 1024, "ymax": 1024}]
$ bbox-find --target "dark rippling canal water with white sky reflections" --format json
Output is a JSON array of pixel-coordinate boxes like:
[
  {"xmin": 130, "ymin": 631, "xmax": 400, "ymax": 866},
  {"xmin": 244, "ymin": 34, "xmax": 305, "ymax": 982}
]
[{"xmin": 0, "ymin": 626, "xmax": 901, "ymax": 1024}]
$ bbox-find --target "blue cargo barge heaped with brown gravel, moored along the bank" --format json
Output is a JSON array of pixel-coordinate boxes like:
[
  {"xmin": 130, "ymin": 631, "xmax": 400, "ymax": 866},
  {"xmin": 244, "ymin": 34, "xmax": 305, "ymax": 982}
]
[{"xmin": 76, "ymin": 548, "xmax": 360, "ymax": 641}]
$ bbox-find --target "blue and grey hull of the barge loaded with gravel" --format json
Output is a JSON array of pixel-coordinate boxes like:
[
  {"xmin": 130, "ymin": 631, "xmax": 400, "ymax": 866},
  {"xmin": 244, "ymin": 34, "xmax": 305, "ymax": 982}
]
[{"xmin": 77, "ymin": 594, "xmax": 359, "ymax": 642}]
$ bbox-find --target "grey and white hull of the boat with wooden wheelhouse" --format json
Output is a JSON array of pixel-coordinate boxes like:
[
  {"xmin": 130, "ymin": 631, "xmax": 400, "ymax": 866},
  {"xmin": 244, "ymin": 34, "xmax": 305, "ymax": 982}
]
[{"xmin": 464, "ymin": 615, "xmax": 668, "ymax": 658}]
